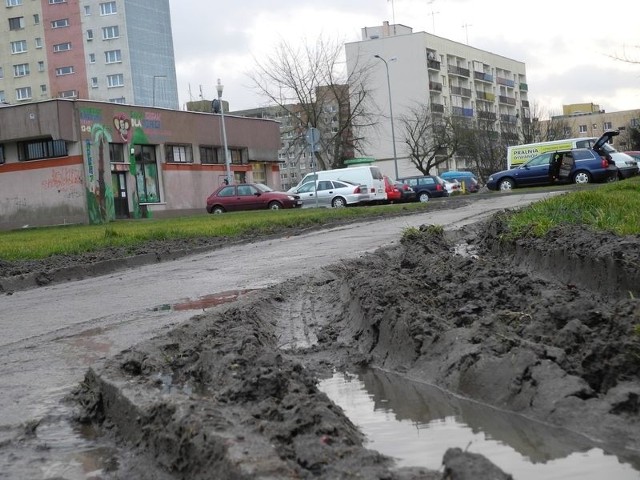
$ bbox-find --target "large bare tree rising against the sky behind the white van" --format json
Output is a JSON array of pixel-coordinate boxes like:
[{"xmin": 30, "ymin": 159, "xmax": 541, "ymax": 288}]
[{"xmin": 249, "ymin": 37, "xmax": 373, "ymax": 169}]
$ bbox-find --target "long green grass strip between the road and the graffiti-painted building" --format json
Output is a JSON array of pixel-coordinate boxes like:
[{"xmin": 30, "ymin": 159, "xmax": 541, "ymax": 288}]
[{"xmin": 0, "ymin": 202, "xmax": 429, "ymax": 261}]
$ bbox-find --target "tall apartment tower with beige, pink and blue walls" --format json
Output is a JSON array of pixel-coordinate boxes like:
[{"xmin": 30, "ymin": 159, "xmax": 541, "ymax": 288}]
[{"xmin": 0, "ymin": 0, "xmax": 179, "ymax": 109}]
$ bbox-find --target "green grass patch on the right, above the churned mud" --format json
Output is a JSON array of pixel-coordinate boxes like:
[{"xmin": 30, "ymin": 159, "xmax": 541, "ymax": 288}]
[{"xmin": 507, "ymin": 177, "xmax": 640, "ymax": 239}]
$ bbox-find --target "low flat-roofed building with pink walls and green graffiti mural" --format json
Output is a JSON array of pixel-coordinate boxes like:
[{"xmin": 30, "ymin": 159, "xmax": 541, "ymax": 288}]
[{"xmin": 0, "ymin": 99, "xmax": 280, "ymax": 230}]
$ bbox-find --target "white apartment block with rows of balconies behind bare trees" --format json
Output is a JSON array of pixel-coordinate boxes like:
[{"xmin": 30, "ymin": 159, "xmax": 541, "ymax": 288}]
[{"xmin": 345, "ymin": 22, "xmax": 530, "ymax": 177}]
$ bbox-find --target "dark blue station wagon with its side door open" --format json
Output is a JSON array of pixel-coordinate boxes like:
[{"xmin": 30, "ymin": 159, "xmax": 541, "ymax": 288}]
[{"xmin": 487, "ymin": 148, "xmax": 618, "ymax": 190}]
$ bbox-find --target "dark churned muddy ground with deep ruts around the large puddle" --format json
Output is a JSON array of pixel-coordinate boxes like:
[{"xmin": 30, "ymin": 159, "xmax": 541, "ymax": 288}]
[{"xmin": 3, "ymin": 212, "xmax": 640, "ymax": 480}]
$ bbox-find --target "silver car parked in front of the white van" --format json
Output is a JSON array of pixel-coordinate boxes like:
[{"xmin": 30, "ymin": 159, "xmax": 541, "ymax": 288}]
[{"xmin": 292, "ymin": 180, "xmax": 371, "ymax": 208}]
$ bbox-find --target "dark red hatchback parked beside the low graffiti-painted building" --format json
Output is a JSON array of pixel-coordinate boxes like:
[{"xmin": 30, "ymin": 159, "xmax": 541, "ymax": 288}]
[{"xmin": 206, "ymin": 183, "xmax": 302, "ymax": 213}]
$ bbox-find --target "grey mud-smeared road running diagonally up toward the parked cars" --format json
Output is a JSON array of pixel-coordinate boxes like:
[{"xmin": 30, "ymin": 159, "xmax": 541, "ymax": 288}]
[{"xmin": 0, "ymin": 192, "xmax": 558, "ymax": 479}]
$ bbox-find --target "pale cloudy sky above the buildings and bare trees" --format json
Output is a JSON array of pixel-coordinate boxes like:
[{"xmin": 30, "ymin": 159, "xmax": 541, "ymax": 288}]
[{"xmin": 170, "ymin": 0, "xmax": 640, "ymax": 117}]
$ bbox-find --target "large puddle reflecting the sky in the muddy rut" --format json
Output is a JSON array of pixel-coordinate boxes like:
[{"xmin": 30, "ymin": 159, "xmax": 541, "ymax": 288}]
[{"xmin": 319, "ymin": 371, "xmax": 640, "ymax": 480}]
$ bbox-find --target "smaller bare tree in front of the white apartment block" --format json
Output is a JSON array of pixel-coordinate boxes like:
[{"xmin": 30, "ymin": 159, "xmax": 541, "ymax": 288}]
[{"xmin": 399, "ymin": 104, "xmax": 463, "ymax": 175}]
